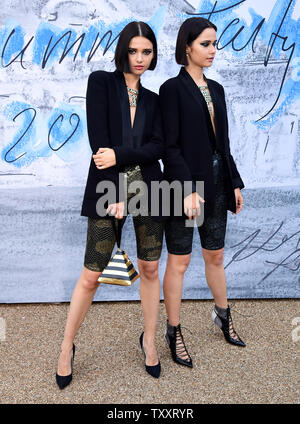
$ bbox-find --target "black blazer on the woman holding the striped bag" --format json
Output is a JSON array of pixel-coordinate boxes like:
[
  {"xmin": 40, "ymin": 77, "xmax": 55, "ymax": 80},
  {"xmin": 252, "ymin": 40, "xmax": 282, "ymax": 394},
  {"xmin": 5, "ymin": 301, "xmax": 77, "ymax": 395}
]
[{"xmin": 81, "ymin": 70, "xmax": 164, "ymax": 219}]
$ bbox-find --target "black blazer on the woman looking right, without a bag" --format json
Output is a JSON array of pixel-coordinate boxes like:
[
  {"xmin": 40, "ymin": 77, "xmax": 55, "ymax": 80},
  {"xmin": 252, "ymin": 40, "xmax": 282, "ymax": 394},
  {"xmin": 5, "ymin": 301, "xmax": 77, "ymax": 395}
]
[{"xmin": 159, "ymin": 67, "xmax": 244, "ymax": 214}]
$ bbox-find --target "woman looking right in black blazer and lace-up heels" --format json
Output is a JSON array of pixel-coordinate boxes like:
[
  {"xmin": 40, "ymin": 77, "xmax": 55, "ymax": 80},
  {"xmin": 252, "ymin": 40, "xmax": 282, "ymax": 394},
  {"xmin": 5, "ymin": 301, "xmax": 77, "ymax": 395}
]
[{"xmin": 159, "ymin": 17, "xmax": 245, "ymax": 367}]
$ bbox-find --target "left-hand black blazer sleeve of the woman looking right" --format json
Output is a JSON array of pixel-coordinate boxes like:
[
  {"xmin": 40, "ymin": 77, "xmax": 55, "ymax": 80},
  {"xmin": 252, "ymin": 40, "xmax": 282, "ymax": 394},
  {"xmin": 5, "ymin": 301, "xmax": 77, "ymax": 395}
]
[{"xmin": 159, "ymin": 80, "xmax": 195, "ymax": 194}]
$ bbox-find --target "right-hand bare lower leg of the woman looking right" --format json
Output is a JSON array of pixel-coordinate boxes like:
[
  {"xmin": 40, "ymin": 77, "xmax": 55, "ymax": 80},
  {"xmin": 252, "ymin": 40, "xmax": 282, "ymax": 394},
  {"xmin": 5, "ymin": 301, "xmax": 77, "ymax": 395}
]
[{"xmin": 202, "ymin": 245, "xmax": 227, "ymax": 309}]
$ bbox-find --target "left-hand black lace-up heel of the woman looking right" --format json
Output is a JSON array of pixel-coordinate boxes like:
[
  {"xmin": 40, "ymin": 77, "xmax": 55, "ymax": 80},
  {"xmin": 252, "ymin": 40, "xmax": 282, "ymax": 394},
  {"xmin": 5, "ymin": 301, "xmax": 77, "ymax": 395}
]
[{"xmin": 165, "ymin": 320, "xmax": 193, "ymax": 368}]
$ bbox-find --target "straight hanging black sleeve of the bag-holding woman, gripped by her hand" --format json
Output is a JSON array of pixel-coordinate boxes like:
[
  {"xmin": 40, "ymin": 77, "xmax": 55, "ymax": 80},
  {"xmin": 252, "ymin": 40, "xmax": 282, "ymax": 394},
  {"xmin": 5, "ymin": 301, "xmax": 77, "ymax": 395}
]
[{"xmin": 86, "ymin": 71, "xmax": 119, "ymax": 202}]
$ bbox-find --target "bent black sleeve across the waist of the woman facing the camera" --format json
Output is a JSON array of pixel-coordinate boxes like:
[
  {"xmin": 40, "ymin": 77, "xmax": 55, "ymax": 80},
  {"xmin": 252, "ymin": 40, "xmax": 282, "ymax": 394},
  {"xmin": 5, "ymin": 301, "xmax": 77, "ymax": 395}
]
[{"xmin": 113, "ymin": 95, "xmax": 164, "ymax": 166}]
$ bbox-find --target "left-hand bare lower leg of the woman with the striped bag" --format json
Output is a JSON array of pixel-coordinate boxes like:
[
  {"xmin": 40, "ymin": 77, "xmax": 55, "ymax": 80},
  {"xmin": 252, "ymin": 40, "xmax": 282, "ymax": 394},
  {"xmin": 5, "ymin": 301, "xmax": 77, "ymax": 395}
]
[{"xmin": 57, "ymin": 267, "xmax": 101, "ymax": 376}]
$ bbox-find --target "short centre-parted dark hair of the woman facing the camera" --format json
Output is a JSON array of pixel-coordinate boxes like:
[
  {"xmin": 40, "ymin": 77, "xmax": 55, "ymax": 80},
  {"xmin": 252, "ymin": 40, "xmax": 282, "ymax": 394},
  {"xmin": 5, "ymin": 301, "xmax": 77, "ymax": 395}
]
[{"xmin": 115, "ymin": 21, "xmax": 157, "ymax": 72}]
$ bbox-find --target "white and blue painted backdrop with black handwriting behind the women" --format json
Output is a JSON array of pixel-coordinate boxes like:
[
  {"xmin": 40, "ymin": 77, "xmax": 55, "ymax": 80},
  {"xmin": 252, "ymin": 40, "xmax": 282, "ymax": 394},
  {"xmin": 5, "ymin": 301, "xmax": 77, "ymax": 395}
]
[{"xmin": 0, "ymin": 0, "xmax": 300, "ymax": 303}]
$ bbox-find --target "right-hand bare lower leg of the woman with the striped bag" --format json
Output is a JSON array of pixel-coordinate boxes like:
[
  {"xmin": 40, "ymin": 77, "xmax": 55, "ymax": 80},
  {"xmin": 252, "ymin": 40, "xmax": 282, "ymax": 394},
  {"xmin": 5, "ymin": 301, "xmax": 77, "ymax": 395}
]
[{"xmin": 138, "ymin": 259, "xmax": 160, "ymax": 366}]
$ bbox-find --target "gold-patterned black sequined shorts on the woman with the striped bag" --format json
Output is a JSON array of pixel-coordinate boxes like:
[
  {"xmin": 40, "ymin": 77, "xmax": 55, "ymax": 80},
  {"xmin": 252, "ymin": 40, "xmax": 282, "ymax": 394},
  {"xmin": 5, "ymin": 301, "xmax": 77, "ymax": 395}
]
[{"xmin": 84, "ymin": 166, "xmax": 164, "ymax": 272}]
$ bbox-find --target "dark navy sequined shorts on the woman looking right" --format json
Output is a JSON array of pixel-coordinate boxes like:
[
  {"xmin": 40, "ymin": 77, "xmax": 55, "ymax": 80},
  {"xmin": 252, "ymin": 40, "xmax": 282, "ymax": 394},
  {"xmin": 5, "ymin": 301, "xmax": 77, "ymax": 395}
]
[{"xmin": 165, "ymin": 153, "xmax": 228, "ymax": 255}]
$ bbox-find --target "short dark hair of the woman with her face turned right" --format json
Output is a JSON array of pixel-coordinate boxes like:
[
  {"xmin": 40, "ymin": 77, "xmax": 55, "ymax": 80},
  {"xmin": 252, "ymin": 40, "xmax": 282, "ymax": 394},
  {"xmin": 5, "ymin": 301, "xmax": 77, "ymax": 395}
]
[{"xmin": 175, "ymin": 17, "xmax": 217, "ymax": 66}]
